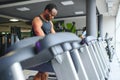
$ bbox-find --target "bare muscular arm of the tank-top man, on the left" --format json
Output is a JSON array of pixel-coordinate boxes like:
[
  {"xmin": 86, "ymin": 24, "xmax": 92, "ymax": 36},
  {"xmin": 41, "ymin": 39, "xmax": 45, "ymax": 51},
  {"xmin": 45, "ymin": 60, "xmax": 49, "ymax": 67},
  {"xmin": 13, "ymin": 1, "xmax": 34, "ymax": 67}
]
[{"xmin": 32, "ymin": 17, "xmax": 45, "ymax": 36}]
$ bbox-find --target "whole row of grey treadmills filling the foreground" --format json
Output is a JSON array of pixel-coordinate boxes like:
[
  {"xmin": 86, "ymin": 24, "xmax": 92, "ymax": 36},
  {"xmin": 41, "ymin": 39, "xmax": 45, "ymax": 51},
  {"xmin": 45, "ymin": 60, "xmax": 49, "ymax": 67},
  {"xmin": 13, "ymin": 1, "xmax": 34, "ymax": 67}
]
[{"xmin": 0, "ymin": 32, "xmax": 110, "ymax": 80}]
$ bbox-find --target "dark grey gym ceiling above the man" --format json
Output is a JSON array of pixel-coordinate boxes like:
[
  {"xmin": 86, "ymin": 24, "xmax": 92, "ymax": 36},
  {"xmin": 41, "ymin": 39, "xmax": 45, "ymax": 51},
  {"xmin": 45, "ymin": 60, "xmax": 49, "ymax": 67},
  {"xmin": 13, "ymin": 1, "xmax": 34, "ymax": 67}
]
[{"xmin": 0, "ymin": 0, "xmax": 119, "ymax": 23}]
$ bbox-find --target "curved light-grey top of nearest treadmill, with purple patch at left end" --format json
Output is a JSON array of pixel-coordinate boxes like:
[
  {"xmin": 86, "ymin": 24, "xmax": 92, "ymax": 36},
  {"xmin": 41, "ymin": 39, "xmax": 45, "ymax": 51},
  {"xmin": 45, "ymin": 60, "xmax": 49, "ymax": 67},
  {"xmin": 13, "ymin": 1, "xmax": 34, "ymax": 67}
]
[{"xmin": 36, "ymin": 32, "xmax": 81, "ymax": 52}]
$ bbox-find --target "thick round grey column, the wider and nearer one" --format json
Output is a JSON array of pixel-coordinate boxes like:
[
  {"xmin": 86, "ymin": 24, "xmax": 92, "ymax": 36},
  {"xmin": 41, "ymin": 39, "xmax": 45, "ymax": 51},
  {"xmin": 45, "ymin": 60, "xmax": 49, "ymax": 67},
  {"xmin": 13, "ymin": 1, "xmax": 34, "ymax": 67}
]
[{"xmin": 86, "ymin": 0, "xmax": 97, "ymax": 37}]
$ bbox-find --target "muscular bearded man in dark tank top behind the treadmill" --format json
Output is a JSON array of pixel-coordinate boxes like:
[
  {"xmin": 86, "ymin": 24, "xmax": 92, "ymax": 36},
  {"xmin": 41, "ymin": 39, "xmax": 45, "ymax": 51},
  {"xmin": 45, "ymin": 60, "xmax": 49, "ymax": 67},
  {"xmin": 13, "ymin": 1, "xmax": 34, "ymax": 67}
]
[{"xmin": 32, "ymin": 4, "xmax": 57, "ymax": 80}]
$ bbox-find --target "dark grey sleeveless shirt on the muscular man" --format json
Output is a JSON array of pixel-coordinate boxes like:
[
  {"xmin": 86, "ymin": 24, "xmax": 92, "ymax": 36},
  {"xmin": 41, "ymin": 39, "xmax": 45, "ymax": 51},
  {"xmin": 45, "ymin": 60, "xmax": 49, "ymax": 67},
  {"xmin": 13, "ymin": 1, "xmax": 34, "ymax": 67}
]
[{"xmin": 32, "ymin": 16, "xmax": 51, "ymax": 36}]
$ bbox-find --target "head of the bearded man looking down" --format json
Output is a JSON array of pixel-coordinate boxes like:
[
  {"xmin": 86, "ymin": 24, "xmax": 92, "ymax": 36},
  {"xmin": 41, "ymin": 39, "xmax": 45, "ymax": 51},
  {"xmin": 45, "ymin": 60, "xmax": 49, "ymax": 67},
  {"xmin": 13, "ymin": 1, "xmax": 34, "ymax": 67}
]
[{"xmin": 44, "ymin": 3, "xmax": 57, "ymax": 21}]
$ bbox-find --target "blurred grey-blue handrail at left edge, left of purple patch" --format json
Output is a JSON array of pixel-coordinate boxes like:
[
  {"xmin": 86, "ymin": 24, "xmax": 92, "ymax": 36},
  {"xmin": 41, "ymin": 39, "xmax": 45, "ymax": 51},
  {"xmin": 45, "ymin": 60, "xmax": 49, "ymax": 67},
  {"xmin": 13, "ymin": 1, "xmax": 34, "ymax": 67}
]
[{"xmin": 0, "ymin": 46, "xmax": 34, "ymax": 72}]
